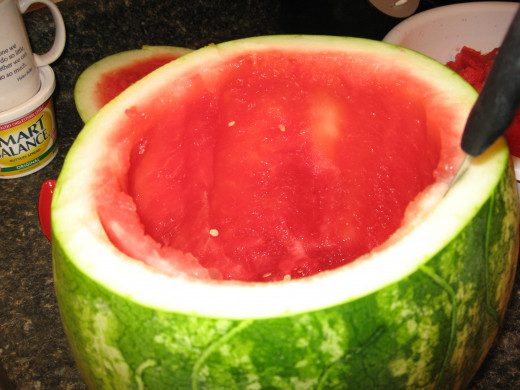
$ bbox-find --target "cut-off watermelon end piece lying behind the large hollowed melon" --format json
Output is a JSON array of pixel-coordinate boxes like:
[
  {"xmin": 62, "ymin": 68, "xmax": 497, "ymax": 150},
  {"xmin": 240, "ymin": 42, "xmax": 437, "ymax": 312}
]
[{"xmin": 74, "ymin": 46, "xmax": 191, "ymax": 122}]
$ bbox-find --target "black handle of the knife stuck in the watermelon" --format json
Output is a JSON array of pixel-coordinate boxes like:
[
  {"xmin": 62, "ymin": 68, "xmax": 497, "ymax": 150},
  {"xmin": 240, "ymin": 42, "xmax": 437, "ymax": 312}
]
[{"xmin": 461, "ymin": 9, "xmax": 520, "ymax": 156}]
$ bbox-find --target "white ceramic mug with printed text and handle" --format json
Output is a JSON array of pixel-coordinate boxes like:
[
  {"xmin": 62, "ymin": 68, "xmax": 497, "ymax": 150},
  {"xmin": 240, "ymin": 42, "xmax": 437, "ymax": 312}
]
[{"xmin": 0, "ymin": 0, "xmax": 65, "ymax": 111}]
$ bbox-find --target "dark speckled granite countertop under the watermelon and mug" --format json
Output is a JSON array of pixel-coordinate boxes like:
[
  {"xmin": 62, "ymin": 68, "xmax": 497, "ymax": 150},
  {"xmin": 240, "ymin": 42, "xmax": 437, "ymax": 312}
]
[{"xmin": 0, "ymin": 0, "xmax": 520, "ymax": 390}]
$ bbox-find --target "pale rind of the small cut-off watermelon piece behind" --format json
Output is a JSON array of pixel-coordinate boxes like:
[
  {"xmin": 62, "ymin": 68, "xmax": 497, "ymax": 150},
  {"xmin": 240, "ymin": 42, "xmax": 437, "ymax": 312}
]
[{"xmin": 74, "ymin": 45, "xmax": 192, "ymax": 123}]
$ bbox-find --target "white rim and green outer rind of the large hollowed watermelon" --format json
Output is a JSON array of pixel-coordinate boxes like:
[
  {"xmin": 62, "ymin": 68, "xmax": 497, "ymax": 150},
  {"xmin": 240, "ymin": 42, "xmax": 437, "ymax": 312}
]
[{"xmin": 52, "ymin": 38, "xmax": 518, "ymax": 389}]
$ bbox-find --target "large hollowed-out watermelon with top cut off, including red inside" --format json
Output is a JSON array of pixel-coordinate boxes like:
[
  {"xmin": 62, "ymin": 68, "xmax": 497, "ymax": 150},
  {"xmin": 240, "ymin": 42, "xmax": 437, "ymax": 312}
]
[{"xmin": 51, "ymin": 36, "xmax": 519, "ymax": 389}]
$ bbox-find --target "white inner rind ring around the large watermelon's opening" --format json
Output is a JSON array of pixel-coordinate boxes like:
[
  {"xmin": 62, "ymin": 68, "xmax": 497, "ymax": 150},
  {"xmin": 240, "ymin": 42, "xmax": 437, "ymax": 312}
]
[{"xmin": 52, "ymin": 37, "xmax": 509, "ymax": 319}]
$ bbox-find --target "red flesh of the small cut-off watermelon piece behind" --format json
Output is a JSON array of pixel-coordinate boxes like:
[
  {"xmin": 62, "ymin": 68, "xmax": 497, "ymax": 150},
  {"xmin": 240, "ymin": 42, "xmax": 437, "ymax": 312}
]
[{"xmin": 96, "ymin": 53, "xmax": 179, "ymax": 107}]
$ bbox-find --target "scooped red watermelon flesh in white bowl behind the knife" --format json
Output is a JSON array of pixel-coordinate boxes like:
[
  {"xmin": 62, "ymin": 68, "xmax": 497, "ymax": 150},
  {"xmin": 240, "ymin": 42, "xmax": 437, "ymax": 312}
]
[{"xmin": 446, "ymin": 46, "xmax": 520, "ymax": 157}]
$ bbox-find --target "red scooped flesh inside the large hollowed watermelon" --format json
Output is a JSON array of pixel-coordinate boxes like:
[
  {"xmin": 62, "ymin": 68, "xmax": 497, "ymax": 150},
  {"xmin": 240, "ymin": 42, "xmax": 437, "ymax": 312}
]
[{"xmin": 97, "ymin": 51, "xmax": 460, "ymax": 281}]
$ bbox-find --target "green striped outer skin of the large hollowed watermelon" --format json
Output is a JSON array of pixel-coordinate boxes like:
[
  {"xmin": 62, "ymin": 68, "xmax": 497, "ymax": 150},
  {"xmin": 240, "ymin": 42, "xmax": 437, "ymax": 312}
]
[{"xmin": 53, "ymin": 159, "xmax": 518, "ymax": 389}]
